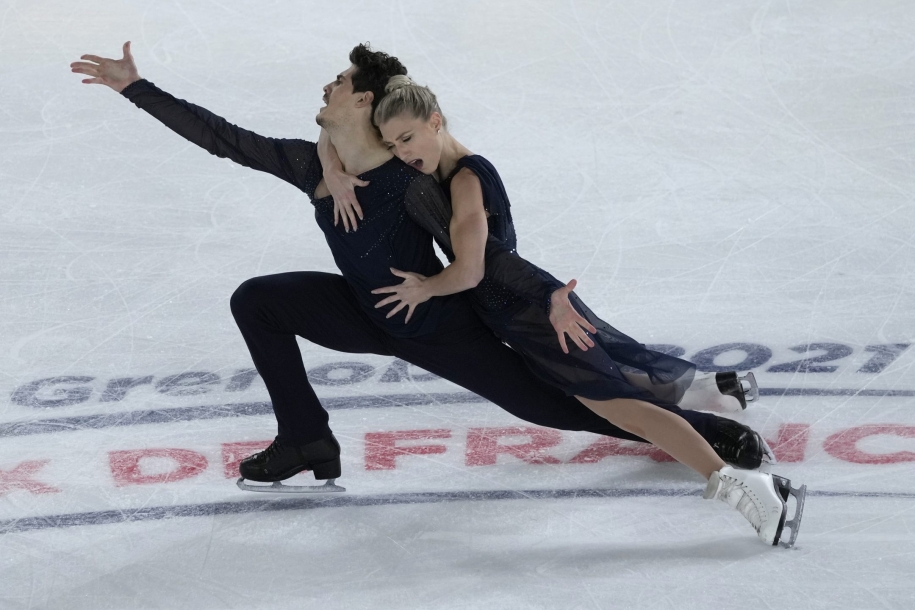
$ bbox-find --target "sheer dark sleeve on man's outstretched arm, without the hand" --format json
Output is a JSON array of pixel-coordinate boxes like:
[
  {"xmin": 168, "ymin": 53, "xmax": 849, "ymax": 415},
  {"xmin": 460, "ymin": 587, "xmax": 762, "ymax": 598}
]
[{"xmin": 121, "ymin": 79, "xmax": 321, "ymax": 197}]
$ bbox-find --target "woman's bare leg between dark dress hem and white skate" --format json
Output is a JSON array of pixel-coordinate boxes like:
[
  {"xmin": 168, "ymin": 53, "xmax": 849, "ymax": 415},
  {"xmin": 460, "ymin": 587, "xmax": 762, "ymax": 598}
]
[{"xmin": 576, "ymin": 396, "xmax": 725, "ymax": 480}]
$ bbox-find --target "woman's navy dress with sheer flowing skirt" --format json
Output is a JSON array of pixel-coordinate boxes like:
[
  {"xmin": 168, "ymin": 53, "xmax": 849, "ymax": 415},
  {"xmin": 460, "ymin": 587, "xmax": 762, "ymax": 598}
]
[{"xmin": 406, "ymin": 155, "xmax": 696, "ymax": 405}]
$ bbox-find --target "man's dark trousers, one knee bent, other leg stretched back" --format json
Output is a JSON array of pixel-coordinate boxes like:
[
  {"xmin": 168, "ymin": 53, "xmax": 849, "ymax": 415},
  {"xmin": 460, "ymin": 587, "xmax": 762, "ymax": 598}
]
[{"xmin": 225, "ymin": 271, "xmax": 717, "ymax": 443}]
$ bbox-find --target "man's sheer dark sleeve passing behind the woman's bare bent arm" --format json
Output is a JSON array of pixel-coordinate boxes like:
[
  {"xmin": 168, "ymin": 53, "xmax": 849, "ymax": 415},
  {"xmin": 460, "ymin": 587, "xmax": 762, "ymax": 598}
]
[{"xmin": 406, "ymin": 175, "xmax": 565, "ymax": 313}]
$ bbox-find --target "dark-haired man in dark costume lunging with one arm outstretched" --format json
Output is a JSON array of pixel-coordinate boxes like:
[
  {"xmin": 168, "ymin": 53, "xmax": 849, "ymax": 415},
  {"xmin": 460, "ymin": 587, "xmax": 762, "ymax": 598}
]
[{"xmin": 71, "ymin": 42, "xmax": 763, "ymax": 481}]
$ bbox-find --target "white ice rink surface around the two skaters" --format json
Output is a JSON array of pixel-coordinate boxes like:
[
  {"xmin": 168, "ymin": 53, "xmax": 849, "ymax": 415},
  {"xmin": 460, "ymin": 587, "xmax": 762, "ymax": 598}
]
[{"xmin": 0, "ymin": 0, "xmax": 915, "ymax": 610}]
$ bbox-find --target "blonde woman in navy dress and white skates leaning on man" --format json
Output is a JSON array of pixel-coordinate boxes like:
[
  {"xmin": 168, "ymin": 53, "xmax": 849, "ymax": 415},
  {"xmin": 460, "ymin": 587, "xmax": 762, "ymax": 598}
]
[{"xmin": 319, "ymin": 76, "xmax": 804, "ymax": 545}]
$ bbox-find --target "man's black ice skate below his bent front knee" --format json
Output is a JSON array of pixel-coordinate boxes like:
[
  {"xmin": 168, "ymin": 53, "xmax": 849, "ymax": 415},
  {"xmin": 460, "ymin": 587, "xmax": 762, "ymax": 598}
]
[{"xmin": 237, "ymin": 435, "xmax": 346, "ymax": 493}]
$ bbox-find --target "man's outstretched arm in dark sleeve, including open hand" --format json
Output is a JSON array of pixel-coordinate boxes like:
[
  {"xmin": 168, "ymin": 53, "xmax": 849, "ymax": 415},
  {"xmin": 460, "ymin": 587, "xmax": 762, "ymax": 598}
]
[{"xmin": 70, "ymin": 42, "xmax": 320, "ymax": 195}]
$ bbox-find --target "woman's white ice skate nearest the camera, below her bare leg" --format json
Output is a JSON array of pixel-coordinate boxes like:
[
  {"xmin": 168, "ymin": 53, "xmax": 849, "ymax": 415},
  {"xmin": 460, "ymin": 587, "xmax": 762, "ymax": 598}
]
[{"xmin": 702, "ymin": 466, "xmax": 807, "ymax": 548}]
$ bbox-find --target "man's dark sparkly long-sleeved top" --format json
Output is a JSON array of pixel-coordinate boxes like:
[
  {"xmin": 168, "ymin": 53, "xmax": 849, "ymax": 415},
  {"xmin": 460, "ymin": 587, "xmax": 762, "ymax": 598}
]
[{"xmin": 121, "ymin": 80, "xmax": 462, "ymax": 337}]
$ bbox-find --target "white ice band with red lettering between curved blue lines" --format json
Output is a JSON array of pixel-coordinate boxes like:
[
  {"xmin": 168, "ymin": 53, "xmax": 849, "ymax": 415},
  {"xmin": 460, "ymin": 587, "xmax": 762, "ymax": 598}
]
[{"xmin": 7, "ymin": 394, "xmax": 915, "ymax": 538}]
